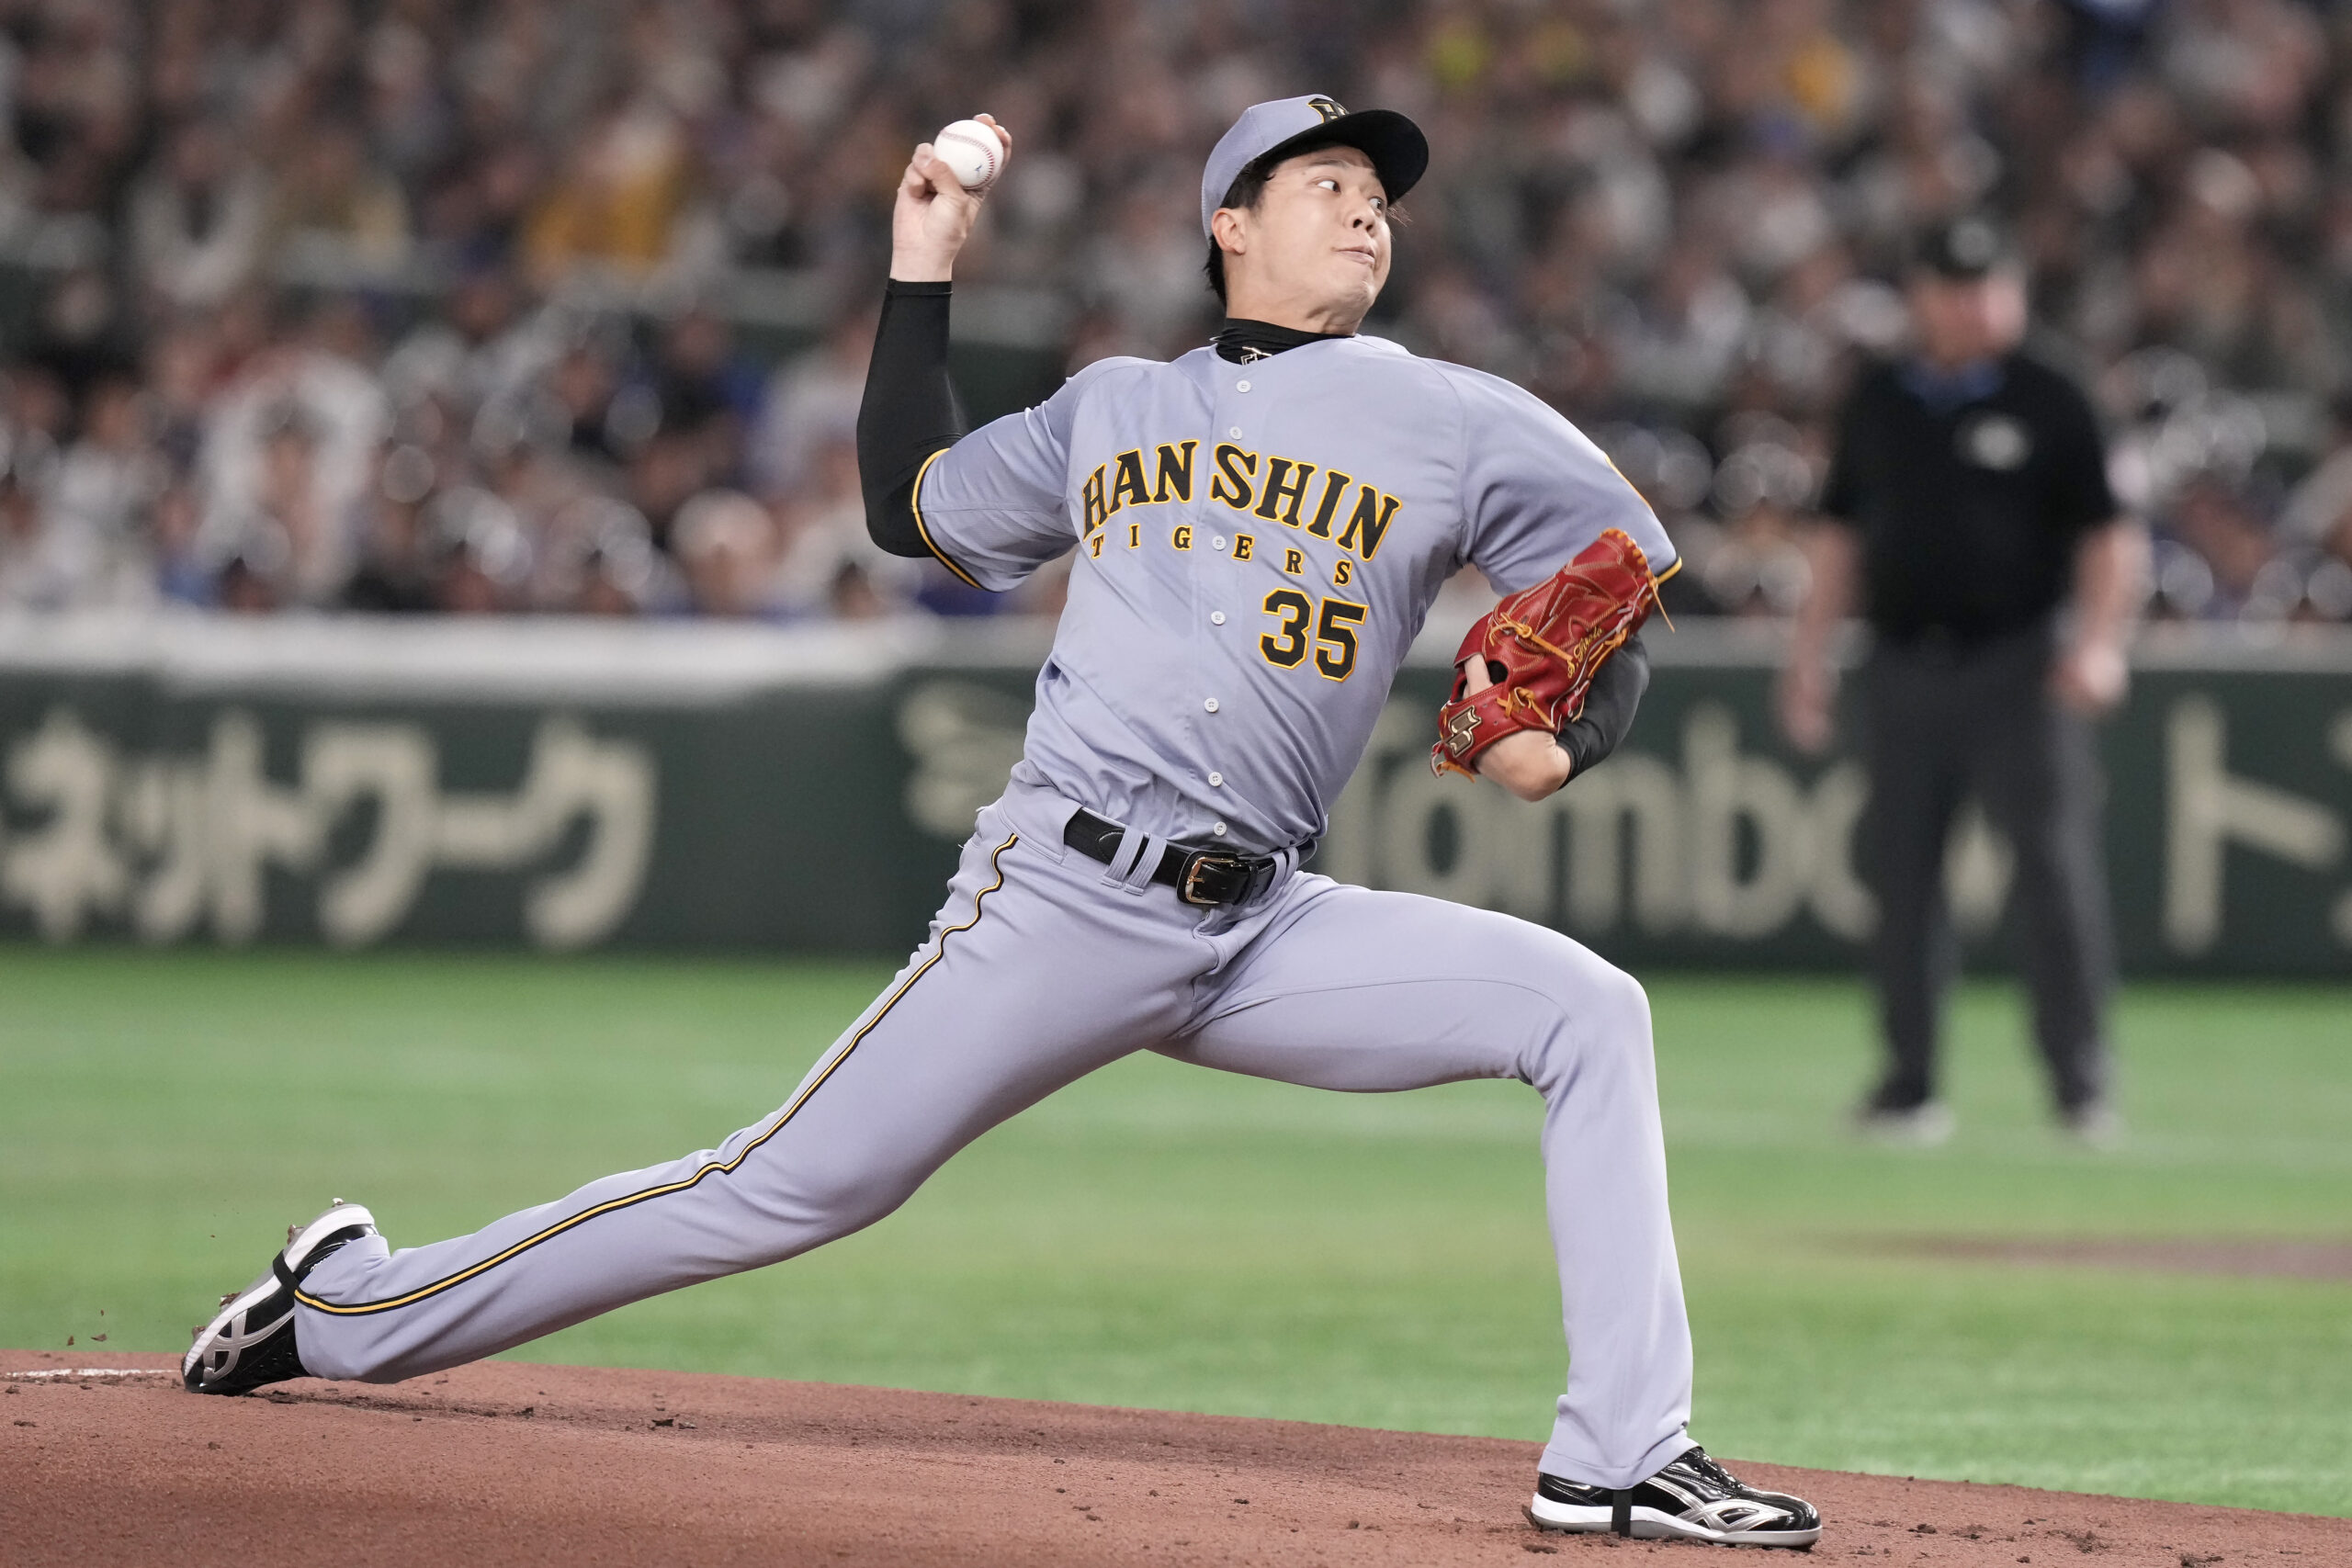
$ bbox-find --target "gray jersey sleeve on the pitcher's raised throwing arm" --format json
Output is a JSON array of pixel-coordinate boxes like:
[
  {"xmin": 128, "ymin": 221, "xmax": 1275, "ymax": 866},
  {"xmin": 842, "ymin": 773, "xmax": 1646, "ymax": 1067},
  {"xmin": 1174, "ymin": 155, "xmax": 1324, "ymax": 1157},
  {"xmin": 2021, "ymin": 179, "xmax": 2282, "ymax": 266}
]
[{"xmin": 915, "ymin": 362, "xmax": 1103, "ymax": 592}]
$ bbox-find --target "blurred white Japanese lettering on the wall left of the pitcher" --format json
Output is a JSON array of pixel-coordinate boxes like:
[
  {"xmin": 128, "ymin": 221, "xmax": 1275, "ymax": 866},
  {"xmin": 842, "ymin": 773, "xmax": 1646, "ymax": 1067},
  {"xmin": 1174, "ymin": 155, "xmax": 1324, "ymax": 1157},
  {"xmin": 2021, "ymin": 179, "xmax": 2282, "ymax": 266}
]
[{"xmin": 0, "ymin": 707, "xmax": 656, "ymax": 947}]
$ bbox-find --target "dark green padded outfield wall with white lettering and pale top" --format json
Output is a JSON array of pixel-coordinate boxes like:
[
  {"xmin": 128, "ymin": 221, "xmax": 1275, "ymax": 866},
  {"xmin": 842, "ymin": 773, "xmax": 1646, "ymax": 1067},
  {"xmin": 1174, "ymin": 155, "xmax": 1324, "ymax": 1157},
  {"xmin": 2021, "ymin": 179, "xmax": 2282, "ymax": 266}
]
[{"xmin": 0, "ymin": 618, "xmax": 2352, "ymax": 976}]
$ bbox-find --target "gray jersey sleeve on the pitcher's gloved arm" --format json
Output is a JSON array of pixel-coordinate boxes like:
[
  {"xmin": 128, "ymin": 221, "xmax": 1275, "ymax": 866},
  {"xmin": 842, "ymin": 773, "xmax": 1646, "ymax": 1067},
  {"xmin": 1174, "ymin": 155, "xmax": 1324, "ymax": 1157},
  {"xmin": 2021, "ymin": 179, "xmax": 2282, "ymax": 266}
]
[{"xmin": 1452, "ymin": 371, "xmax": 1675, "ymax": 592}]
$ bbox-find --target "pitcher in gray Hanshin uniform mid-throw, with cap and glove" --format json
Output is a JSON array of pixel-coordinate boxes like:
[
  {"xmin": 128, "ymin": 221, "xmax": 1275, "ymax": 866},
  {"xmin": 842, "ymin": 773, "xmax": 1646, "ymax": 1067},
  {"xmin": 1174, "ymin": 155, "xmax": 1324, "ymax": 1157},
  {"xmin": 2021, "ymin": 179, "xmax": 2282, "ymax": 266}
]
[{"xmin": 186, "ymin": 96, "xmax": 1820, "ymax": 1547}]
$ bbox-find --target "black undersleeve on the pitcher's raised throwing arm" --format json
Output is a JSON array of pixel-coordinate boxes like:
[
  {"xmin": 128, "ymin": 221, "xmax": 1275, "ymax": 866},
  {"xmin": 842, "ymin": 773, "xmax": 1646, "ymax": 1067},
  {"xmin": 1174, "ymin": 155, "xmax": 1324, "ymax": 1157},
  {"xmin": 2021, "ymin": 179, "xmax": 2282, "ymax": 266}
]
[{"xmin": 858, "ymin": 280, "xmax": 969, "ymax": 559}]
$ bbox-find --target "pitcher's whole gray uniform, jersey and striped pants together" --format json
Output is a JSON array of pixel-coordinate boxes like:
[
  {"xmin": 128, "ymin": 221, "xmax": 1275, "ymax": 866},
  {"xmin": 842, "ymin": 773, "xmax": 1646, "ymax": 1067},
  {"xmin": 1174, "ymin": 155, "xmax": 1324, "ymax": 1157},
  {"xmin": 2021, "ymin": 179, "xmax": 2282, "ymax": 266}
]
[{"xmin": 294, "ymin": 339, "xmax": 1691, "ymax": 1485}]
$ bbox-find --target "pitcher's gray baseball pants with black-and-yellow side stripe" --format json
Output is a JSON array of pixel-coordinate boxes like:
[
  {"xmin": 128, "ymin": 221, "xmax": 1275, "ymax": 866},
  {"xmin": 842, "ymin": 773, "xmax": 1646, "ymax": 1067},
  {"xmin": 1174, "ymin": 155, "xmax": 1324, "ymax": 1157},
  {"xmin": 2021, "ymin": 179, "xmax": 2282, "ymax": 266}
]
[{"xmin": 297, "ymin": 785, "xmax": 1691, "ymax": 1485}]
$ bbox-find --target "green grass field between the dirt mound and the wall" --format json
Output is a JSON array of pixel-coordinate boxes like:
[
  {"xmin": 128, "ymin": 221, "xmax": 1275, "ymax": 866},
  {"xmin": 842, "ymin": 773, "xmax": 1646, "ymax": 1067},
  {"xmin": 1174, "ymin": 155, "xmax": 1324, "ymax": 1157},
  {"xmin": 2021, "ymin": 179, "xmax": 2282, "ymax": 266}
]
[{"xmin": 0, "ymin": 947, "xmax": 2352, "ymax": 1517}]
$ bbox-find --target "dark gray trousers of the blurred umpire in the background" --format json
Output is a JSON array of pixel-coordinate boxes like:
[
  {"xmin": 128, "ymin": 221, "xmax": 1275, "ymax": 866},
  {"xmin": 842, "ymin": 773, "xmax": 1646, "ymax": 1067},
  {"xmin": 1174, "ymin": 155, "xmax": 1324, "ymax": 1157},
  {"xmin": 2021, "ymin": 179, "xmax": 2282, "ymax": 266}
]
[{"xmin": 1863, "ymin": 627, "xmax": 2114, "ymax": 1110}]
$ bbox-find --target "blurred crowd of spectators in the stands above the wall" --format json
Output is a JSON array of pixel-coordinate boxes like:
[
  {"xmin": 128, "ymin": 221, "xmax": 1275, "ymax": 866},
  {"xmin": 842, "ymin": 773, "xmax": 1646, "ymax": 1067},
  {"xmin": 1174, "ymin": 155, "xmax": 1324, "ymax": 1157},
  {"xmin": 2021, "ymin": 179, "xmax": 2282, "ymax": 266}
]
[{"xmin": 0, "ymin": 0, "xmax": 2352, "ymax": 621}]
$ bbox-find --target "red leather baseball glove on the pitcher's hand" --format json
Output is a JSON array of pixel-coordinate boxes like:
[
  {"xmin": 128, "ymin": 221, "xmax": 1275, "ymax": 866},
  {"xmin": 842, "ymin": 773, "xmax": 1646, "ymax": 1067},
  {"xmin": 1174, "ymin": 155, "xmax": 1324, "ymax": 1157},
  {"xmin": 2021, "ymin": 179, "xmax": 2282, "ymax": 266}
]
[{"xmin": 1430, "ymin": 529, "xmax": 1658, "ymax": 776}]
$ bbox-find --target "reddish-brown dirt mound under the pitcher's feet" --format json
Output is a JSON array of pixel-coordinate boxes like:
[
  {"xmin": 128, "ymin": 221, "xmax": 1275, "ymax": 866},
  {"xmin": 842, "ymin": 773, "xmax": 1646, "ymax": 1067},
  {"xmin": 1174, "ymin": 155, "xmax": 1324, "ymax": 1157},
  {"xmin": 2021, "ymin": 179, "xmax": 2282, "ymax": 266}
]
[{"xmin": 0, "ymin": 1347, "xmax": 2352, "ymax": 1568}]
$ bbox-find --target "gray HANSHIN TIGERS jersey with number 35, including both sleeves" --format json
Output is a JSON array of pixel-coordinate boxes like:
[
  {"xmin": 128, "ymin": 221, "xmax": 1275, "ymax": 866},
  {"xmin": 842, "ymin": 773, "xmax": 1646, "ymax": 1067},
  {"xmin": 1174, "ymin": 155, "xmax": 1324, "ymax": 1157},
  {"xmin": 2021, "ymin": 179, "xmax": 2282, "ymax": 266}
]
[{"xmin": 915, "ymin": 336, "xmax": 1675, "ymax": 851}]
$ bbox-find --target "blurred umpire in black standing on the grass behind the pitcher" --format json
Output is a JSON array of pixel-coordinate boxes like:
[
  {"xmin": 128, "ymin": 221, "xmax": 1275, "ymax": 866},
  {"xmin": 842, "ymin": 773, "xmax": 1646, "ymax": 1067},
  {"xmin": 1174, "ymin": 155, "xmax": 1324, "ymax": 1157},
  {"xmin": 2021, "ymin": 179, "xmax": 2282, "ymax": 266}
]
[{"xmin": 1778, "ymin": 216, "xmax": 2147, "ymax": 1143}]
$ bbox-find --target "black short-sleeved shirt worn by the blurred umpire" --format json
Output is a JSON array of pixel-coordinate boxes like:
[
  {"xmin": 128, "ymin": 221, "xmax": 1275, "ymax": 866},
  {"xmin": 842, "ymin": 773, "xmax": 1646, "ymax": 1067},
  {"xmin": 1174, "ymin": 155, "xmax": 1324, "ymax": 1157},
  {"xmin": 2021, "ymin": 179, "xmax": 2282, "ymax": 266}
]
[{"xmin": 1820, "ymin": 353, "xmax": 2117, "ymax": 647}]
